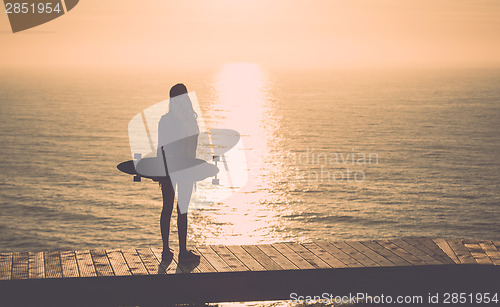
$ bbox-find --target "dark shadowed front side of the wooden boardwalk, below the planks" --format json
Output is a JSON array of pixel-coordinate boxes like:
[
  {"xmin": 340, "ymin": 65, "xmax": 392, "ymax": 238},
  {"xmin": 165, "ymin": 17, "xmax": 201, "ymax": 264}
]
[{"xmin": 0, "ymin": 263, "xmax": 500, "ymax": 307}]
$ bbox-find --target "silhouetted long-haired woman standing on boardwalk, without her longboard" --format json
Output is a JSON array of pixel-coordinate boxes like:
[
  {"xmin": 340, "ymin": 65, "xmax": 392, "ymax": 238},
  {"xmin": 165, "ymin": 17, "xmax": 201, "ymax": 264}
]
[{"xmin": 157, "ymin": 84, "xmax": 200, "ymax": 262}]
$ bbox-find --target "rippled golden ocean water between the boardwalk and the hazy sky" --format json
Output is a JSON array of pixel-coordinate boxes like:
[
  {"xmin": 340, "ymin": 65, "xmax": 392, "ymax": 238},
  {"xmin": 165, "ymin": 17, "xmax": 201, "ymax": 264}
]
[{"xmin": 0, "ymin": 64, "xmax": 500, "ymax": 258}]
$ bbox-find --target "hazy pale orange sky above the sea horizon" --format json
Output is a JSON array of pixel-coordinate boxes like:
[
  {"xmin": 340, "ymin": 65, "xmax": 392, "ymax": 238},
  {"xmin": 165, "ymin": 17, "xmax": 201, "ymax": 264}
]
[{"xmin": 0, "ymin": 0, "xmax": 500, "ymax": 69}]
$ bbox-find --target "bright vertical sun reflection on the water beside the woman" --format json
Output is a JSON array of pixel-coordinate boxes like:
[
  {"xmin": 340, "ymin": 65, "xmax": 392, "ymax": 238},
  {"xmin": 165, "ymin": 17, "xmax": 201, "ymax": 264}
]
[{"xmin": 193, "ymin": 63, "xmax": 292, "ymax": 244}]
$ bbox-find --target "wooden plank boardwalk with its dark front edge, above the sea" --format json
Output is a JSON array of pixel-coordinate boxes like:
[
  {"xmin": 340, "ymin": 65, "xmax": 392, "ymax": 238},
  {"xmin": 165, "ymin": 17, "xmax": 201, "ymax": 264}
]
[{"xmin": 0, "ymin": 238, "xmax": 500, "ymax": 306}]
